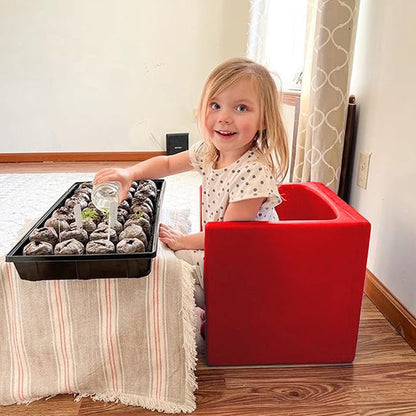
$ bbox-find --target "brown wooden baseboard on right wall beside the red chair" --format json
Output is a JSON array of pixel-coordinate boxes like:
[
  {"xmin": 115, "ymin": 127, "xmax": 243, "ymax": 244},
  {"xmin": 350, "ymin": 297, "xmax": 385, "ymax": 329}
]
[{"xmin": 364, "ymin": 270, "xmax": 416, "ymax": 351}]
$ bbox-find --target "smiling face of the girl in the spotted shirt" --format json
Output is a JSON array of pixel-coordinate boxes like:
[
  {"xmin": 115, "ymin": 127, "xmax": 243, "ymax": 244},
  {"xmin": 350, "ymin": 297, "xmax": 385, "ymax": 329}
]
[{"xmin": 205, "ymin": 78, "xmax": 260, "ymax": 163}]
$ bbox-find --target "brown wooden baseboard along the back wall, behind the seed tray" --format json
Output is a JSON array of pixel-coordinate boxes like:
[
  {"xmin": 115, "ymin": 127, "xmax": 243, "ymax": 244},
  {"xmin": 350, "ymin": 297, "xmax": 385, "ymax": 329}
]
[{"xmin": 0, "ymin": 152, "xmax": 166, "ymax": 163}]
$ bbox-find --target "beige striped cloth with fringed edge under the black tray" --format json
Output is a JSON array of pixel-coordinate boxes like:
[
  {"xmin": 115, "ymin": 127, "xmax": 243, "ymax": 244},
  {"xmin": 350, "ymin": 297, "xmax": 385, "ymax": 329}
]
[{"xmin": 0, "ymin": 171, "xmax": 197, "ymax": 413}]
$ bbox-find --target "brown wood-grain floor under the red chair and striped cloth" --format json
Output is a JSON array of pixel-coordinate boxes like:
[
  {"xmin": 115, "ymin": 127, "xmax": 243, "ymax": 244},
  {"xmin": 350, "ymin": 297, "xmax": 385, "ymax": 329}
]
[{"xmin": 0, "ymin": 163, "xmax": 416, "ymax": 416}]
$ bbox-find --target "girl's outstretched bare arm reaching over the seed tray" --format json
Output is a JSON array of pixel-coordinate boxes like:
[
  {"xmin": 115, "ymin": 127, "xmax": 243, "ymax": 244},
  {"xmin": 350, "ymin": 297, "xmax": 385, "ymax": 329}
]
[{"xmin": 94, "ymin": 151, "xmax": 193, "ymax": 199}]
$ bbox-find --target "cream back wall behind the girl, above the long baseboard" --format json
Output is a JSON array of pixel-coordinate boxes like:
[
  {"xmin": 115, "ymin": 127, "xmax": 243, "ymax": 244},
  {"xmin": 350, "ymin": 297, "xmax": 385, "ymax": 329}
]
[{"xmin": 0, "ymin": 0, "xmax": 249, "ymax": 153}]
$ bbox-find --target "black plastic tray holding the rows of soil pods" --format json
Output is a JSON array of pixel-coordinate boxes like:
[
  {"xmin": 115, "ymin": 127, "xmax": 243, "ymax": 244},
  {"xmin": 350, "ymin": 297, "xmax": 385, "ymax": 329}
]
[{"xmin": 6, "ymin": 179, "xmax": 165, "ymax": 281}]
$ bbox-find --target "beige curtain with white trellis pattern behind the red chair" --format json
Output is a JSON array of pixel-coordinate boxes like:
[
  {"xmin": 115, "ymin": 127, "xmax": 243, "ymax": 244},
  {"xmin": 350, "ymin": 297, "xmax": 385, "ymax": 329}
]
[{"xmin": 293, "ymin": 0, "xmax": 359, "ymax": 192}]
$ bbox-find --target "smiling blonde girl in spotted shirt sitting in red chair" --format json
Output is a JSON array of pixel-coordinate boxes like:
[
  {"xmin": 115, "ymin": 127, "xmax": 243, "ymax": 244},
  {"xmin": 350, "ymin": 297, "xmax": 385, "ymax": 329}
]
[{"xmin": 94, "ymin": 58, "xmax": 288, "ymax": 306}]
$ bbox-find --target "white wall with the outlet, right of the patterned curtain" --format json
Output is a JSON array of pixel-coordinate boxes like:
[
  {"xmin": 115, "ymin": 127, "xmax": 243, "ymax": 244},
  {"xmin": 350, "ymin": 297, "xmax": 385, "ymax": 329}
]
[{"xmin": 351, "ymin": 0, "xmax": 416, "ymax": 316}]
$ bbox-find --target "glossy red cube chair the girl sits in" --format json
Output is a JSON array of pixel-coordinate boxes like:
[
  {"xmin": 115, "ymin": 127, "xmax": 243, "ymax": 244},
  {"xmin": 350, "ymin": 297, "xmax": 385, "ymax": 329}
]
[{"xmin": 204, "ymin": 182, "xmax": 370, "ymax": 366}]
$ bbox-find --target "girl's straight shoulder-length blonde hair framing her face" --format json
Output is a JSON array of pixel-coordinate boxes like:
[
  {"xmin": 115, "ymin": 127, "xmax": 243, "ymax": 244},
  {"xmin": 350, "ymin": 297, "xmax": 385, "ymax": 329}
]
[{"xmin": 198, "ymin": 58, "xmax": 289, "ymax": 182}]
